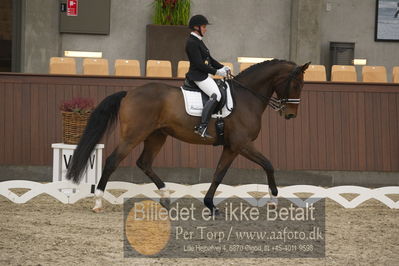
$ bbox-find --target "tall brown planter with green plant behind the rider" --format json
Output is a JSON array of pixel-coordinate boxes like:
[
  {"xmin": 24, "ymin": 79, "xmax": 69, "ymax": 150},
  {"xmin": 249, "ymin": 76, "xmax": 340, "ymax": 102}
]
[{"xmin": 146, "ymin": 0, "xmax": 191, "ymax": 76}]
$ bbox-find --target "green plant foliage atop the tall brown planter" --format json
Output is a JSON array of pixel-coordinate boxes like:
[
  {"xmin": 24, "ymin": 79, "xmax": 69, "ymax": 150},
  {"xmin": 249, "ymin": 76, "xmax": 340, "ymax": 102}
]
[{"xmin": 153, "ymin": 0, "xmax": 191, "ymax": 26}]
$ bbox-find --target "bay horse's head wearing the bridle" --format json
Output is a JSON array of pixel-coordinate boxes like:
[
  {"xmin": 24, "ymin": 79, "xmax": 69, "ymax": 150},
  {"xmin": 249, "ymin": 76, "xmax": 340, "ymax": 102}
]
[{"xmin": 275, "ymin": 62, "xmax": 310, "ymax": 119}]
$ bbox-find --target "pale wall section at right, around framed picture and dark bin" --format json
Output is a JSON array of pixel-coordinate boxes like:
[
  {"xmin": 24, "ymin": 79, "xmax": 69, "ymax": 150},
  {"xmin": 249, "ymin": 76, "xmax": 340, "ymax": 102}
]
[{"xmin": 321, "ymin": 0, "xmax": 399, "ymax": 81}]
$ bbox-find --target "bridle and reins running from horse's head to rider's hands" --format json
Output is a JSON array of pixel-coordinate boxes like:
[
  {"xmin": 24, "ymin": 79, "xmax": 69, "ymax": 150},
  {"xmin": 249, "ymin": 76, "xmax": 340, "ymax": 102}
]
[{"xmin": 227, "ymin": 67, "xmax": 301, "ymax": 111}]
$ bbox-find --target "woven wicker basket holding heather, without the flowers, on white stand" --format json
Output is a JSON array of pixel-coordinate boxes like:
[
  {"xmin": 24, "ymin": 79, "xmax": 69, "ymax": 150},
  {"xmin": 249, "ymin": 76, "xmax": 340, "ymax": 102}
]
[{"xmin": 61, "ymin": 112, "xmax": 90, "ymax": 144}]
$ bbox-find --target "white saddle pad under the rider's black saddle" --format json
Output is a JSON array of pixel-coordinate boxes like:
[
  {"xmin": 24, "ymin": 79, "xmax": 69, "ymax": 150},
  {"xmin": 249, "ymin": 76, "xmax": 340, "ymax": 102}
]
[{"xmin": 180, "ymin": 83, "xmax": 233, "ymax": 118}]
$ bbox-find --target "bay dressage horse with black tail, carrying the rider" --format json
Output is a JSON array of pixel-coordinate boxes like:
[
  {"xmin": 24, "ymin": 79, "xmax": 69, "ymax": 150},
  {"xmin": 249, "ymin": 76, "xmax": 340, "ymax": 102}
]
[{"xmin": 66, "ymin": 59, "xmax": 310, "ymax": 212}]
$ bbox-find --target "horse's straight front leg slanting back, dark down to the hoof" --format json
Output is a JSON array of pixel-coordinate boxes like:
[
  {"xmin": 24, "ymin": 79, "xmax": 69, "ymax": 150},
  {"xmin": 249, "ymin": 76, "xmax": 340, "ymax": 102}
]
[{"xmin": 204, "ymin": 146, "xmax": 238, "ymax": 214}]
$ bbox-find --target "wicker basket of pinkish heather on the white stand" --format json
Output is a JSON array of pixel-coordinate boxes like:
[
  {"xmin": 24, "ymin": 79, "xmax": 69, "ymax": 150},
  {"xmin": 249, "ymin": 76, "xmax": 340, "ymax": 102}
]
[{"xmin": 60, "ymin": 98, "xmax": 94, "ymax": 144}]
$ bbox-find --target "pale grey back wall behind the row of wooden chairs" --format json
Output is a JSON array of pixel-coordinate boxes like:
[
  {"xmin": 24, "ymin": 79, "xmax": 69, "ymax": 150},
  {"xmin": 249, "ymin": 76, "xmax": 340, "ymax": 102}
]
[{"xmin": 22, "ymin": 0, "xmax": 399, "ymax": 81}]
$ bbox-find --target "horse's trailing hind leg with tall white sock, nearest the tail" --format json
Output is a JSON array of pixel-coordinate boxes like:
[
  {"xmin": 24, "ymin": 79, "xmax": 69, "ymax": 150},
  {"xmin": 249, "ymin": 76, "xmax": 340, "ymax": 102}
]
[{"xmin": 93, "ymin": 141, "xmax": 139, "ymax": 212}]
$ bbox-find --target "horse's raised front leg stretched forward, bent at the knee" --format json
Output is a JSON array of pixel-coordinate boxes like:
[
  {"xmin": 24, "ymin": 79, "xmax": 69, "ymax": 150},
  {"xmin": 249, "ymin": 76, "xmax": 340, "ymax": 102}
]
[{"xmin": 240, "ymin": 143, "xmax": 278, "ymax": 206}]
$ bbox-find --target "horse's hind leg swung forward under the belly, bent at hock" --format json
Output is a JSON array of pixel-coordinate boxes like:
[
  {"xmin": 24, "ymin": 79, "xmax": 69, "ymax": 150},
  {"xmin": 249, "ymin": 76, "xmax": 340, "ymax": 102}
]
[{"xmin": 136, "ymin": 130, "xmax": 170, "ymax": 208}]
